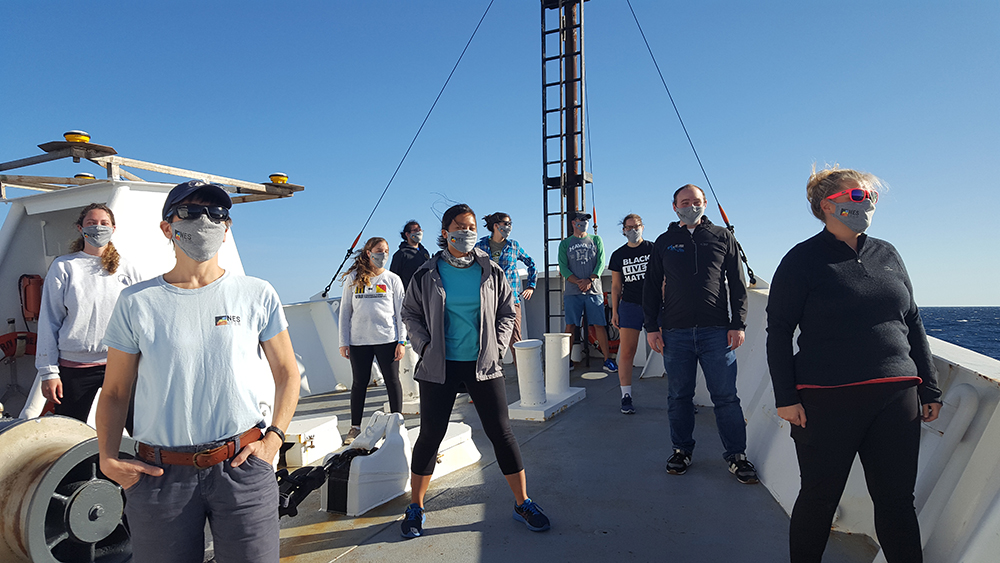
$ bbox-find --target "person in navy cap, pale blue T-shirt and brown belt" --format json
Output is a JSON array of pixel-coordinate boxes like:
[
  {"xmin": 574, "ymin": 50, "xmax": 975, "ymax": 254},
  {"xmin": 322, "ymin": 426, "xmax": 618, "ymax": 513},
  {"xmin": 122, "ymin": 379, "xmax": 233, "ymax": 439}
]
[{"xmin": 97, "ymin": 181, "xmax": 299, "ymax": 563}]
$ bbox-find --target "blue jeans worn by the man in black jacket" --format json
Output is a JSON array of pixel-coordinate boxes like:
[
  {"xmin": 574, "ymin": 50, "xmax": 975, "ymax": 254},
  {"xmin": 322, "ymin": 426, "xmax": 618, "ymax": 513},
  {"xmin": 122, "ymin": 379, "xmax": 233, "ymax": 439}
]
[{"xmin": 662, "ymin": 327, "xmax": 747, "ymax": 459}]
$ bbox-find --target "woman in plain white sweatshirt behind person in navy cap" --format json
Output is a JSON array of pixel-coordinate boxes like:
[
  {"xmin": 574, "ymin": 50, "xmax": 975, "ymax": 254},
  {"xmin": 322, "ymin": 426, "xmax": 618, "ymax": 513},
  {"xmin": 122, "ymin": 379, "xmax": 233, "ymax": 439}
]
[{"xmin": 35, "ymin": 203, "xmax": 140, "ymax": 426}]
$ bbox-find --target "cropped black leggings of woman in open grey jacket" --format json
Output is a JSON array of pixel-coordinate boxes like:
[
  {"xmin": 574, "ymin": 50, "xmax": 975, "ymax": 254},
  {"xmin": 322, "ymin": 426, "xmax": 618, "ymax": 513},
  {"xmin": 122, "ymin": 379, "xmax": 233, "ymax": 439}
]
[{"xmin": 410, "ymin": 361, "xmax": 524, "ymax": 475}]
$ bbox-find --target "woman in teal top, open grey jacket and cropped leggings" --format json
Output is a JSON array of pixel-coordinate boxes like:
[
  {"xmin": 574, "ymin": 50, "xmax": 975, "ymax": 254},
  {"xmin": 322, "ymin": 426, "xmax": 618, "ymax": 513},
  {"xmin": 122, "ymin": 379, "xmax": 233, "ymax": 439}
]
[{"xmin": 402, "ymin": 204, "xmax": 549, "ymax": 538}]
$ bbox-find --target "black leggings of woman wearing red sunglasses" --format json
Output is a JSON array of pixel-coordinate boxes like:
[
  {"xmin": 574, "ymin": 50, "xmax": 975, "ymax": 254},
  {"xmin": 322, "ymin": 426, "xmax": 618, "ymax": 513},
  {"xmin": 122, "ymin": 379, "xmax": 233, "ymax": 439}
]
[{"xmin": 789, "ymin": 382, "xmax": 923, "ymax": 563}]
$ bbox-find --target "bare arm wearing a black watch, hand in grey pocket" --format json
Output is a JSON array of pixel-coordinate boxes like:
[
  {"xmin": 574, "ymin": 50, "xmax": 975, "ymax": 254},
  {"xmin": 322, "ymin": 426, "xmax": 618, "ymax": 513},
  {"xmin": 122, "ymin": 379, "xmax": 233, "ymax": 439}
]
[{"xmin": 232, "ymin": 330, "xmax": 301, "ymax": 467}]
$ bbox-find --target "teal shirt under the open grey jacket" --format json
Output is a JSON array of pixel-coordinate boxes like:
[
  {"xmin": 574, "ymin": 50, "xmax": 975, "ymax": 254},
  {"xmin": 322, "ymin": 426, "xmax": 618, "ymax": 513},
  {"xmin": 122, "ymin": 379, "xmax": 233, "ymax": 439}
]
[{"xmin": 438, "ymin": 260, "xmax": 483, "ymax": 362}]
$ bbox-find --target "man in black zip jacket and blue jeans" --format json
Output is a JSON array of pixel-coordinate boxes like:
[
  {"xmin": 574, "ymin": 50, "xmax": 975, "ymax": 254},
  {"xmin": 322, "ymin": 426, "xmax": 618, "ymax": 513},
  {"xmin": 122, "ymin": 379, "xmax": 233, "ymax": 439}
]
[{"xmin": 642, "ymin": 184, "xmax": 757, "ymax": 483}]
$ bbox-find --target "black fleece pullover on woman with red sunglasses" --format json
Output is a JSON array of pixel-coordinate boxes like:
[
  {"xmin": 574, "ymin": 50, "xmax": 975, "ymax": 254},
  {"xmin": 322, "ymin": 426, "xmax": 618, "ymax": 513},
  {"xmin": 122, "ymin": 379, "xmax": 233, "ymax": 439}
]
[{"xmin": 767, "ymin": 229, "xmax": 941, "ymax": 407}]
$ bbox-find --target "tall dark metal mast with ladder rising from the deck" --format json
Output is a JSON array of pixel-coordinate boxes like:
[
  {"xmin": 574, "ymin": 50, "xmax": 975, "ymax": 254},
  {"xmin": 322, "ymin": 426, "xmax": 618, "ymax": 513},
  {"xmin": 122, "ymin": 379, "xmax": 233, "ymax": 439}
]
[{"xmin": 542, "ymin": 0, "xmax": 593, "ymax": 332}]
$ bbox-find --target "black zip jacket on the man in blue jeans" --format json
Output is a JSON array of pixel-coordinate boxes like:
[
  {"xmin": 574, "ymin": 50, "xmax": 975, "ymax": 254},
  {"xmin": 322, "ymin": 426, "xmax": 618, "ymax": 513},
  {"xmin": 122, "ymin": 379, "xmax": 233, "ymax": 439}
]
[{"xmin": 642, "ymin": 217, "xmax": 747, "ymax": 332}]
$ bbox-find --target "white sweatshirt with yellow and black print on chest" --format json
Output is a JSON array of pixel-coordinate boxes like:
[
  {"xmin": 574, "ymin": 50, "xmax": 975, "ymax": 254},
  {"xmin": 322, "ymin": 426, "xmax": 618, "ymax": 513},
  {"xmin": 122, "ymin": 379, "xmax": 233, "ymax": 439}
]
[{"xmin": 340, "ymin": 270, "xmax": 406, "ymax": 346}]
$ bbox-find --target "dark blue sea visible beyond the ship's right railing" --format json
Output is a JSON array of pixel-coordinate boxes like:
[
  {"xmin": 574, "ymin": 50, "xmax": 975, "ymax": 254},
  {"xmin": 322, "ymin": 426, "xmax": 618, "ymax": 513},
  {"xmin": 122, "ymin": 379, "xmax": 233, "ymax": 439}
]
[{"xmin": 920, "ymin": 307, "xmax": 1000, "ymax": 360}]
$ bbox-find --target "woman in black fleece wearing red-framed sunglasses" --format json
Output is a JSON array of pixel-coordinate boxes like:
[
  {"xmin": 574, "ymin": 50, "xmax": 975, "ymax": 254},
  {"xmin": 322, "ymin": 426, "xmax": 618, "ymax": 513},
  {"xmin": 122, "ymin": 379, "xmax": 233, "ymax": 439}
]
[{"xmin": 767, "ymin": 168, "xmax": 941, "ymax": 563}]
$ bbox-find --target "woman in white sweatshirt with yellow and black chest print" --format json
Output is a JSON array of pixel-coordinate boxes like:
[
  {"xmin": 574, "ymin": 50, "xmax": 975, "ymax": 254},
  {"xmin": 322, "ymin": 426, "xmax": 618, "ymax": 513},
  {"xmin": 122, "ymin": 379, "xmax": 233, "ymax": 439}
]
[{"xmin": 340, "ymin": 237, "xmax": 406, "ymax": 444}]
